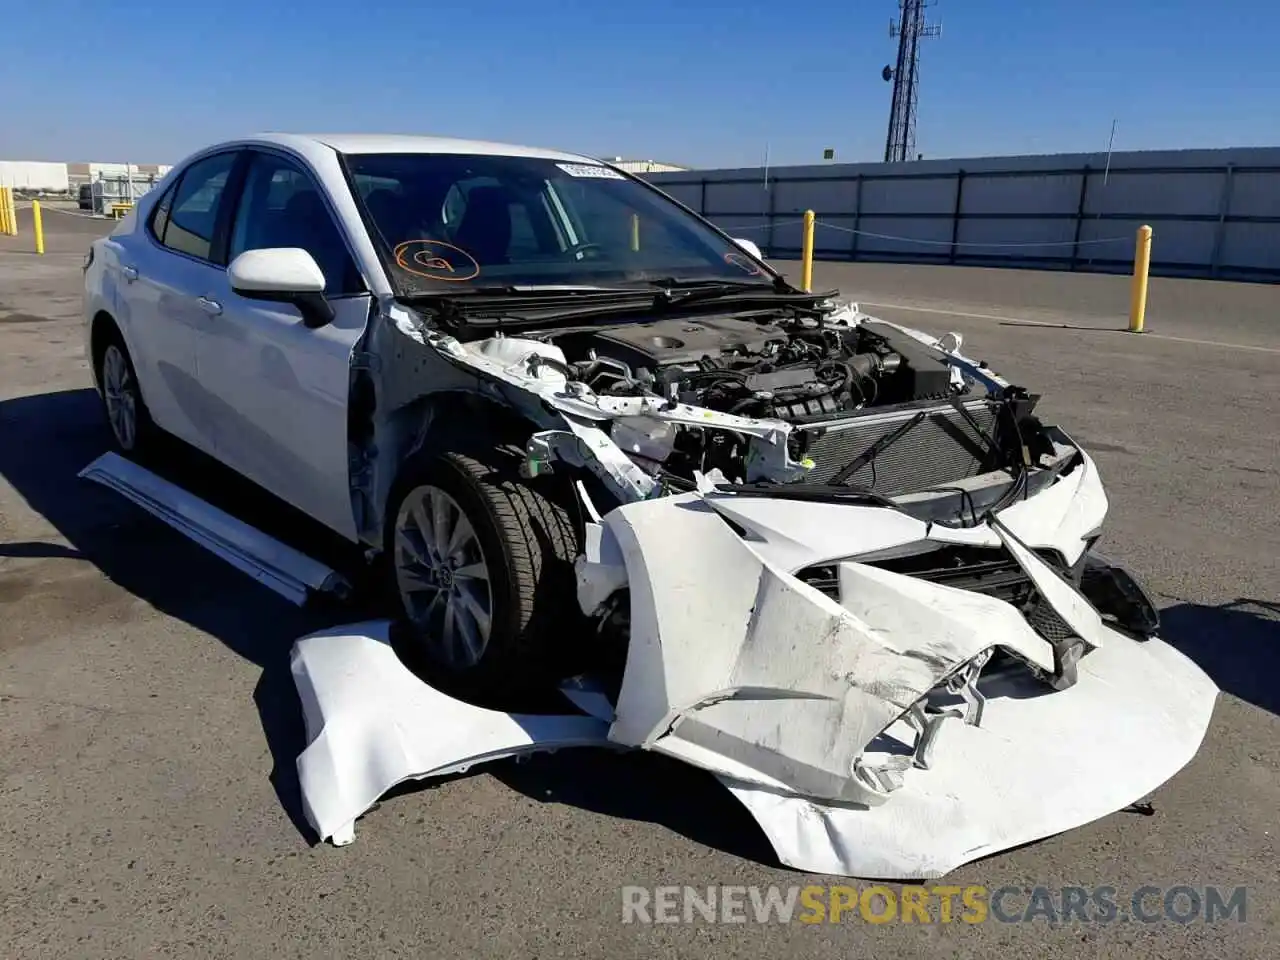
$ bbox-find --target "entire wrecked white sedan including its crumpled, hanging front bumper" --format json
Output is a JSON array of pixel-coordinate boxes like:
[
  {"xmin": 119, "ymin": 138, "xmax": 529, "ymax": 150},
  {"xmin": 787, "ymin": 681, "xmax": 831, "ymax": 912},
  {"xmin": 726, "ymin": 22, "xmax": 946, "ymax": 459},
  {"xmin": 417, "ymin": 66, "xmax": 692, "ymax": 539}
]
[{"xmin": 86, "ymin": 134, "xmax": 1216, "ymax": 876}]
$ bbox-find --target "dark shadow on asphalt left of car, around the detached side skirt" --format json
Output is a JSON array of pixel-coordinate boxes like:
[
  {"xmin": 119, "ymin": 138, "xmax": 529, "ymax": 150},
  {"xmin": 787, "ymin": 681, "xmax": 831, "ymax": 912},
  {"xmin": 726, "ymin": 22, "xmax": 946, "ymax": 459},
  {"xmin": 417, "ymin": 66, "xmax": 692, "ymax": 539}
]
[{"xmin": 0, "ymin": 389, "xmax": 347, "ymax": 837}]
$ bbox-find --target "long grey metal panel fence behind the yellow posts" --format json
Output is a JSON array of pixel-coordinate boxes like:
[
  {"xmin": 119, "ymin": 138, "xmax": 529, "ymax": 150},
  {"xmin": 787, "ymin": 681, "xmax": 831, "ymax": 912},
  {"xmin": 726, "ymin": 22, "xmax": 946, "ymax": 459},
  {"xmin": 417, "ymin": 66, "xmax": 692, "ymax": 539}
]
[{"xmin": 646, "ymin": 148, "xmax": 1280, "ymax": 282}]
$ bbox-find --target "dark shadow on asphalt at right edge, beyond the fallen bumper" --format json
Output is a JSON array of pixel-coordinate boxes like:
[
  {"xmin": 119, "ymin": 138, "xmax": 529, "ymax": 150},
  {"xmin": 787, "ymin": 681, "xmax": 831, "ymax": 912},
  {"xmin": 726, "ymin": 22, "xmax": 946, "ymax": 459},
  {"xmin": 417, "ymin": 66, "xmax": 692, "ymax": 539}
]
[{"xmin": 1160, "ymin": 596, "xmax": 1280, "ymax": 716}]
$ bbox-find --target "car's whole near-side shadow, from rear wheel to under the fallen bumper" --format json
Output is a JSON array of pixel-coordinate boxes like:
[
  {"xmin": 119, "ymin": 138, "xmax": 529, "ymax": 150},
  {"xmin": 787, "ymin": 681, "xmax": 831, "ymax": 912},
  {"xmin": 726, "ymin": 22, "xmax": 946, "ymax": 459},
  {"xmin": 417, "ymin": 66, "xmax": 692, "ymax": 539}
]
[{"xmin": 0, "ymin": 389, "xmax": 776, "ymax": 863}]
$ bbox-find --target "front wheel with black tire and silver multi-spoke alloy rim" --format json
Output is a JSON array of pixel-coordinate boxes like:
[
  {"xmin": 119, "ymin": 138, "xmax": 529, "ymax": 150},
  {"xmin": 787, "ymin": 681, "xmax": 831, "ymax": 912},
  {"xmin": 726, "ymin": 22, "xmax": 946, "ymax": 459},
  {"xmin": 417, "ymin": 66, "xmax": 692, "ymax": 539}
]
[{"xmin": 384, "ymin": 451, "xmax": 584, "ymax": 695}]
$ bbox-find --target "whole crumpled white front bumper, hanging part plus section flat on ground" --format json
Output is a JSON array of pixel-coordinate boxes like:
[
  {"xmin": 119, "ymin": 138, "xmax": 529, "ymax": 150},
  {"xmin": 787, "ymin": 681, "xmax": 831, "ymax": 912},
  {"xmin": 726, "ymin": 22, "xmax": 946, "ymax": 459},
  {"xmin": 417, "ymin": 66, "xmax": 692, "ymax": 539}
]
[{"xmin": 580, "ymin": 481, "xmax": 1217, "ymax": 878}]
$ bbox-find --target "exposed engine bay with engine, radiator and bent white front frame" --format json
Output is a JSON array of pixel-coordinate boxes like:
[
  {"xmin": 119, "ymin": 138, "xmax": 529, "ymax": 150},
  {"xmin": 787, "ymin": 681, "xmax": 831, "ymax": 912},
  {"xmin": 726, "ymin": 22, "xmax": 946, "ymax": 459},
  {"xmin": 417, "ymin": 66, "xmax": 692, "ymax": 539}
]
[{"xmin": 424, "ymin": 302, "xmax": 1053, "ymax": 506}]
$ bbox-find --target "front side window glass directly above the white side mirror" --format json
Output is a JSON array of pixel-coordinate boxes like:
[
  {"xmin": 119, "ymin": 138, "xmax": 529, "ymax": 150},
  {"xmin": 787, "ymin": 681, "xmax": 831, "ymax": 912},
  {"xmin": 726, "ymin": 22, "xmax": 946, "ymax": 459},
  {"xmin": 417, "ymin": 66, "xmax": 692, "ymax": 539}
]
[{"xmin": 228, "ymin": 154, "xmax": 365, "ymax": 297}]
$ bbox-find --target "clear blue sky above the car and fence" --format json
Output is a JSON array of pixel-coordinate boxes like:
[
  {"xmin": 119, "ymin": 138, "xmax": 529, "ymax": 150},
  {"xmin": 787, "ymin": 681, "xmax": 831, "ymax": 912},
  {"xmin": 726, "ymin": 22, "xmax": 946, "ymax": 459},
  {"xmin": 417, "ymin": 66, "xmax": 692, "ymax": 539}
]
[{"xmin": 0, "ymin": 0, "xmax": 1280, "ymax": 166}]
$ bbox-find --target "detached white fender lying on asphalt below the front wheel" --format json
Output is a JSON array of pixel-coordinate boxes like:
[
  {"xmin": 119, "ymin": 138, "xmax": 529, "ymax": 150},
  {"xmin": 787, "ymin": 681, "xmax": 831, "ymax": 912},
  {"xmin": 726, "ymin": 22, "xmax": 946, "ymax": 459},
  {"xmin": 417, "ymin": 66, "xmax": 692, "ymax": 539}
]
[{"xmin": 292, "ymin": 621, "xmax": 608, "ymax": 846}]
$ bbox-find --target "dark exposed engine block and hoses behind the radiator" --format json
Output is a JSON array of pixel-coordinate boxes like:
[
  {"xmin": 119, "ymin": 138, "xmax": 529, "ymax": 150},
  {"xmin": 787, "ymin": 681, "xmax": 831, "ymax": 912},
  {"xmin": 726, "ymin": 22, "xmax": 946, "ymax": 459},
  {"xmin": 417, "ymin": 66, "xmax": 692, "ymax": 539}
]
[{"xmin": 554, "ymin": 317, "xmax": 950, "ymax": 422}]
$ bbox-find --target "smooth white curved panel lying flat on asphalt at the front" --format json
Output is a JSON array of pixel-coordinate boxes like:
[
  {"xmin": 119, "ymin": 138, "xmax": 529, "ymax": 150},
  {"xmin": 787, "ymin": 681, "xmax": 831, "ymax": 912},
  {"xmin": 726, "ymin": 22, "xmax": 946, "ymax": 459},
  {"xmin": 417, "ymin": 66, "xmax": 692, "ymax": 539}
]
[{"xmin": 722, "ymin": 631, "xmax": 1217, "ymax": 881}]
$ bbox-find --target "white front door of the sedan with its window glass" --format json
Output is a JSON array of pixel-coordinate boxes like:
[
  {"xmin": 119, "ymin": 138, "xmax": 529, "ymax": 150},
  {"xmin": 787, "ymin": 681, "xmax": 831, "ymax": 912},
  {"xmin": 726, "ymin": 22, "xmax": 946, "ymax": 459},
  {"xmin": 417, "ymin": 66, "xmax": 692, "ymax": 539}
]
[{"xmin": 197, "ymin": 150, "xmax": 371, "ymax": 539}]
